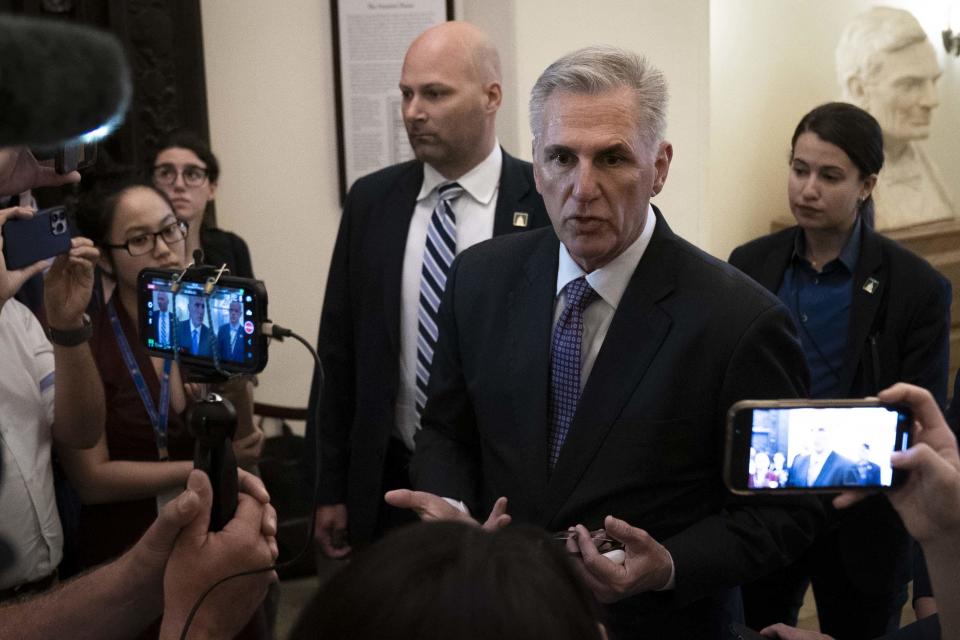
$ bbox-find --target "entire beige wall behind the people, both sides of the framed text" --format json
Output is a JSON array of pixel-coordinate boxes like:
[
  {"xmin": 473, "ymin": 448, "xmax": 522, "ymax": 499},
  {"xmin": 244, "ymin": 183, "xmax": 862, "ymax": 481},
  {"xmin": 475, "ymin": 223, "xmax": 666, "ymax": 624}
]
[{"xmin": 202, "ymin": 0, "xmax": 960, "ymax": 405}]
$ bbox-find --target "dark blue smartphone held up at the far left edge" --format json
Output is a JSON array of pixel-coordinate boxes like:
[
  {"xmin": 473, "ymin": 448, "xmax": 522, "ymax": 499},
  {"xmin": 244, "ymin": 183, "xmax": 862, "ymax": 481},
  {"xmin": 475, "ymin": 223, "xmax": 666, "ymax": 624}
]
[{"xmin": 2, "ymin": 207, "xmax": 70, "ymax": 270}]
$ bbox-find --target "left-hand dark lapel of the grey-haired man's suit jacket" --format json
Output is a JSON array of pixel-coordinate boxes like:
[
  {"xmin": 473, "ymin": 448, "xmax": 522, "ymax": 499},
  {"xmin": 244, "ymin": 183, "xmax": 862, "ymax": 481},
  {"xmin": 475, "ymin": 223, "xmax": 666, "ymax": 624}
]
[{"xmin": 506, "ymin": 231, "xmax": 560, "ymax": 495}]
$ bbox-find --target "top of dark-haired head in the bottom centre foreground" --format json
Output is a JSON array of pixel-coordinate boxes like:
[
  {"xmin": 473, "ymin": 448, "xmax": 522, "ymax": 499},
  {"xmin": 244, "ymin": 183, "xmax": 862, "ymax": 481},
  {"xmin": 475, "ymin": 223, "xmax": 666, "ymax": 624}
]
[{"xmin": 289, "ymin": 522, "xmax": 601, "ymax": 640}]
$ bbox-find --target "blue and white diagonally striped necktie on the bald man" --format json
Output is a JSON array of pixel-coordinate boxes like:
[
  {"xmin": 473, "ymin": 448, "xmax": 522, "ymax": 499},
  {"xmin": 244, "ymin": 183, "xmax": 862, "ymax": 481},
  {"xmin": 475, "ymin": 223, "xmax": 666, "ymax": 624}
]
[{"xmin": 416, "ymin": 182, "xmax": 463, "ymax": 415}]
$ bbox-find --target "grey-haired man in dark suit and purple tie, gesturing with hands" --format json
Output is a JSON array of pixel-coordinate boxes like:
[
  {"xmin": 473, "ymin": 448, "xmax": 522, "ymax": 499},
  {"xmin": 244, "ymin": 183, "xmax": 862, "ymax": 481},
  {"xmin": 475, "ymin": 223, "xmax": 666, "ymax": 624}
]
[{"xmin": 387, "ymin": 47, "xmax": 821, "ymax": 640}]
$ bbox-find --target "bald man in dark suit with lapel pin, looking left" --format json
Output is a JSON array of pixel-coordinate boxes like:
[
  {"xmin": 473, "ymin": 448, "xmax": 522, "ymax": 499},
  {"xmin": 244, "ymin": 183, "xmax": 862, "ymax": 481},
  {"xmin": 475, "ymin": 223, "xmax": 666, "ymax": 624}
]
[{"xmin": 306, "ymin": 22, "xmax": 548, "ymax": 557}]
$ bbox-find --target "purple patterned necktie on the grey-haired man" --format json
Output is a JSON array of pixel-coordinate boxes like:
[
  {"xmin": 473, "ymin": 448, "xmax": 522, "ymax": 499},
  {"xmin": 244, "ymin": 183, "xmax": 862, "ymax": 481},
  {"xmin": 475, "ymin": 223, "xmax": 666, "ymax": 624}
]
[{"xmin": 548, "ymin": 276, "xmax": 597, "ymax": 471}]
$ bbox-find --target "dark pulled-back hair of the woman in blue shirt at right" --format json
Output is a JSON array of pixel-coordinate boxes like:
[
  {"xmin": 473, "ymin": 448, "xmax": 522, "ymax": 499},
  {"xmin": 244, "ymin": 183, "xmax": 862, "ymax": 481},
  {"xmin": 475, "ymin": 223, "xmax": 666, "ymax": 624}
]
[{"xmin": 790, "ymin": 102, "xmax": 883, "ymax": 227}]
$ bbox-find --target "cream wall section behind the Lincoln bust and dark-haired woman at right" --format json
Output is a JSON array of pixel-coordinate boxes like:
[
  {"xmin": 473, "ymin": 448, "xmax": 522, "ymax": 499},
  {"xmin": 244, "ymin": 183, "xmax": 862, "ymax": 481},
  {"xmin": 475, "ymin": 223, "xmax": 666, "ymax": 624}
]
[{"xmin": 704, "ymin": 0, "xmax": 960, "ymax": 258}]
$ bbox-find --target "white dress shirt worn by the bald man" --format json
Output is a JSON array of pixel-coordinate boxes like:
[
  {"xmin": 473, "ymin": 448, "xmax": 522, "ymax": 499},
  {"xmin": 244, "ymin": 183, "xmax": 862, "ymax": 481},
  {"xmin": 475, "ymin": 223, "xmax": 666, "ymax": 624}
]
[{"xmin": 394, "ymin": 142, "xmax": 503, "ymax": 451}]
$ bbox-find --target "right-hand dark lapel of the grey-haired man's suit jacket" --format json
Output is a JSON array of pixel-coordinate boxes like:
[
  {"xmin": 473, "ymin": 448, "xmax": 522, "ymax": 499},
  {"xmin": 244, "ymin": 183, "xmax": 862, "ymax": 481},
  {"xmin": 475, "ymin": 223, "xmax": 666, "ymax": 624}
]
[{"xmin": 539, "ymin": 215, "xmax": 676, "ymax": 523}]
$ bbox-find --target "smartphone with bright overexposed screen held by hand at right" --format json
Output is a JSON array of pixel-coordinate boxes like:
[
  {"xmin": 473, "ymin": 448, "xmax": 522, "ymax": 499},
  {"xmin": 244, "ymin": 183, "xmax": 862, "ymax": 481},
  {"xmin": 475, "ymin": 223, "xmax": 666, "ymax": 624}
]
[{"xmin": 724, "ymin": 400, "xmax": 913, "ymax": 494}]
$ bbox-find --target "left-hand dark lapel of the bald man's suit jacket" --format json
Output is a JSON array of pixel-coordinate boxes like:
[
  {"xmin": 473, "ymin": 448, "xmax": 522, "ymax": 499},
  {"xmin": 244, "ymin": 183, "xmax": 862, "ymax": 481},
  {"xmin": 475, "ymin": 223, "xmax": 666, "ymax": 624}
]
[{"xmin": 382, "ymin": 162, "xmax": 423, "ymax": 356}]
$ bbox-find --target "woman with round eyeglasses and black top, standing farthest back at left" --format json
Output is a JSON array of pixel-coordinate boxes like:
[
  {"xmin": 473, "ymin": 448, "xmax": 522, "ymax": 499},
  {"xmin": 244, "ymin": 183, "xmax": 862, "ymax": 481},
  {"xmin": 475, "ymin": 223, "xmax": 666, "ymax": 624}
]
[{"xmin": 150, "ymin": 131, "xmax": 253, "ymax": 278}]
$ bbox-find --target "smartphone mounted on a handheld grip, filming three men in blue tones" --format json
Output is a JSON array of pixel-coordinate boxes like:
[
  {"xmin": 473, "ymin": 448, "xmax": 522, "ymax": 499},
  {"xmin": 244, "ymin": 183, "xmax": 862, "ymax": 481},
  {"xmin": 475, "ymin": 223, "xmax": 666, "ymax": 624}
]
[{"xmin": 138, "ymin": 269, "xmax": 267, "ymax": 373}]
